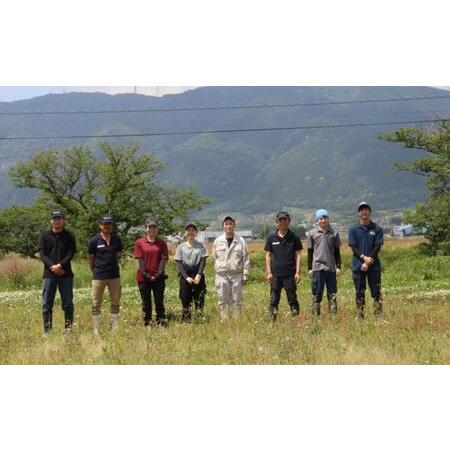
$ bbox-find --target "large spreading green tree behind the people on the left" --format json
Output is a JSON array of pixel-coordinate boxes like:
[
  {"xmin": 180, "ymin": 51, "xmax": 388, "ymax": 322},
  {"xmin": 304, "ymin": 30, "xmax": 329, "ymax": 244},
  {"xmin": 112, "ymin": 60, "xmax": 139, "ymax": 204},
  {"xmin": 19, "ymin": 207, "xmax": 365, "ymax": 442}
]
[{"xmin": 10, "ymin": 142, "xmax": 208, "ymax": 250}]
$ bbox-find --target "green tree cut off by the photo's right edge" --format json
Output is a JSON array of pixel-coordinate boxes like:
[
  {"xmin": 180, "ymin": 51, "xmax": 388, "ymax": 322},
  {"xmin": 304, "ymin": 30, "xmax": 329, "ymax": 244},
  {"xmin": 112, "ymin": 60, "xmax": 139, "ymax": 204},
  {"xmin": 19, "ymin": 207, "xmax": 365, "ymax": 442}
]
[{"xmin": 380, "ymin": 120, "xmax": 450, "ymax": 254}]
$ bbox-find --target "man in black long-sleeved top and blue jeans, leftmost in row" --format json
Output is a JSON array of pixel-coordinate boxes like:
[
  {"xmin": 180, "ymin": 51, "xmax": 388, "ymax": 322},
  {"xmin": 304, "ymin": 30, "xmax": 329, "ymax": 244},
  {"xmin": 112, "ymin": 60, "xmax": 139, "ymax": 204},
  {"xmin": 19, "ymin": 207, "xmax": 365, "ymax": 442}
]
[{"xmin": 39, "ymin": 211, "xmax": 77, "ymax": 335}]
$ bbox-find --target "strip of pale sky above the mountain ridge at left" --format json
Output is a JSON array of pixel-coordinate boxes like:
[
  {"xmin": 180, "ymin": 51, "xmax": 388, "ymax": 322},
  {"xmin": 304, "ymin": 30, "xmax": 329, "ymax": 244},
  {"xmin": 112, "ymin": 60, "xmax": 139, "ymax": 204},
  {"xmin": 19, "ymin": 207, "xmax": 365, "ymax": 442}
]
[{"xmin": 0, "ymin": 86, "xmax": 195, "ymax": 102}]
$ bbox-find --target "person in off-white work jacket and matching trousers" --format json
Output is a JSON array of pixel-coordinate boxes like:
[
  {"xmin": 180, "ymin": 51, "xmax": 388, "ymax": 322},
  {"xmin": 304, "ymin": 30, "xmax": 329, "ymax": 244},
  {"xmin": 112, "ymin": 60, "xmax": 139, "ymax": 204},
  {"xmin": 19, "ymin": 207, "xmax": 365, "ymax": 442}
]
[{"xmin": 212, "ymin": 216, "xmax": 250, "ymax": 322}]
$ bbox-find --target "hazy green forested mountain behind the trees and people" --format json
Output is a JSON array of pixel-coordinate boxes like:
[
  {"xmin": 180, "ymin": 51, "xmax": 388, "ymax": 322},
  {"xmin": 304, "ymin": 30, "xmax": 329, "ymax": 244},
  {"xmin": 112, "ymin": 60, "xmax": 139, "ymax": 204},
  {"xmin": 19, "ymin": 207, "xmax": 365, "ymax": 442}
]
[{"xmin": 0, "ymin": 87, "xmax": 450, "ymax": 220}]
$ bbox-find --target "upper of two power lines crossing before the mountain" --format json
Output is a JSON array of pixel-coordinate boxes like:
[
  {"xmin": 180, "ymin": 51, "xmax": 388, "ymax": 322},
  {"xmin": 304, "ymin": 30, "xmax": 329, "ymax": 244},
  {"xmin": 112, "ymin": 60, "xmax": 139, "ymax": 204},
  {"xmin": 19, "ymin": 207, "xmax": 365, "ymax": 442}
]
[{"xmin": 0, "ymin": 95, "xmax": 450, "ymax": 116}]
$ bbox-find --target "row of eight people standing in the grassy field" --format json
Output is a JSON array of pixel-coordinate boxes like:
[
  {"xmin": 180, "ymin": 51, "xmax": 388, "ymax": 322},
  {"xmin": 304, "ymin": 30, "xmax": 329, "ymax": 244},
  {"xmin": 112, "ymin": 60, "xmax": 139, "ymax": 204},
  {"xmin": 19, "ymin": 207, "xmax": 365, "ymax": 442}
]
[{"xmin": 39, "ymin": 202, "xmax": 383, "ymax": 335}]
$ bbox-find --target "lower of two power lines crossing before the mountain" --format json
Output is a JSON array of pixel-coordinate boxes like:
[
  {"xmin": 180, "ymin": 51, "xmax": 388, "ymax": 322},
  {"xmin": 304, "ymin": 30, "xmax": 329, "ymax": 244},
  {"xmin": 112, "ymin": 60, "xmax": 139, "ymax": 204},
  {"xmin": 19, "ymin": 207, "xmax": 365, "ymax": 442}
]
[{"xmin": 0, "ymin": 118, "xmax": 444, "ymax": 141}]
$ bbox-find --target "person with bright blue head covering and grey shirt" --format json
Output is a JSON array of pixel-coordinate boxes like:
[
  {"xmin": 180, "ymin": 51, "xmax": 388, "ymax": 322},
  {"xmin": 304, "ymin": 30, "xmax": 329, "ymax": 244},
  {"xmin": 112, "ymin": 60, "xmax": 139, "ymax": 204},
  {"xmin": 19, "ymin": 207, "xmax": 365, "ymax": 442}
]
[{"xmin": 307, "ymin": 209, "xmax": 341, "ymax": 316}]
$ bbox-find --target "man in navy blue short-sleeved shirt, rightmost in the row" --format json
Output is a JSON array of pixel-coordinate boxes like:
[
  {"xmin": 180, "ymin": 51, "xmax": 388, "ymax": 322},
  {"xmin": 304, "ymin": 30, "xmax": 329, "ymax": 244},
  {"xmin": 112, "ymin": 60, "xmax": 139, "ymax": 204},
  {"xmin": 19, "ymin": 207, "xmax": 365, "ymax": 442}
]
[{"xmin": 348, "ymin": 202, "xmax": 383, "ymax": 319}]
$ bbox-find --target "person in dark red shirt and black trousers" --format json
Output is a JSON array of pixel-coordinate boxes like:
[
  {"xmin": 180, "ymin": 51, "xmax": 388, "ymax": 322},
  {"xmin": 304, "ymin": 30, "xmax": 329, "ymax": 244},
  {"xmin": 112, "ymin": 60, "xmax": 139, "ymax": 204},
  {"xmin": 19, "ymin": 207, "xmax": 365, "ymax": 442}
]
[{"xmin": 134, "ymin": 219, "xmax": 169, "ymax": 327}]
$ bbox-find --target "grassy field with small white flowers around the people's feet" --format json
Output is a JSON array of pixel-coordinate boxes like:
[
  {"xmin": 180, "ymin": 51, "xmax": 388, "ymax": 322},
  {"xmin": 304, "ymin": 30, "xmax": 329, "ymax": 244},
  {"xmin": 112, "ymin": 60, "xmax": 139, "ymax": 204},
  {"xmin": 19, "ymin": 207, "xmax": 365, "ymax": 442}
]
[{"xmin": 0, "ymin": 240, "xmax": 450, "ymax": 364}]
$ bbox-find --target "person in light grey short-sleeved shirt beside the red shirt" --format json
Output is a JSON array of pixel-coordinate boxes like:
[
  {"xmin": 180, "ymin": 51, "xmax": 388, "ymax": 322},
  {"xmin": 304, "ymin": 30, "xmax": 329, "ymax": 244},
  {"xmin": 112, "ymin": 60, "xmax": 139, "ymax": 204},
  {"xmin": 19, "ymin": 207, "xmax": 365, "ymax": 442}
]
[{"xmin": 175, "ymin": 223, "xmax": 208, "ymax": 322}]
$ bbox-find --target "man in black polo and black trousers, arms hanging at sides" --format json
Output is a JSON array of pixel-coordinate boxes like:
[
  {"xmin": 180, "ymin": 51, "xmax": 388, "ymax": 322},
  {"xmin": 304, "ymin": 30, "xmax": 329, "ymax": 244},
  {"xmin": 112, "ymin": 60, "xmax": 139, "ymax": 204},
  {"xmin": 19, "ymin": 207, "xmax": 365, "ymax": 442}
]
[{"xmin": 264, "ymin": 211, "xmax": 303, "ymax": 320}]
